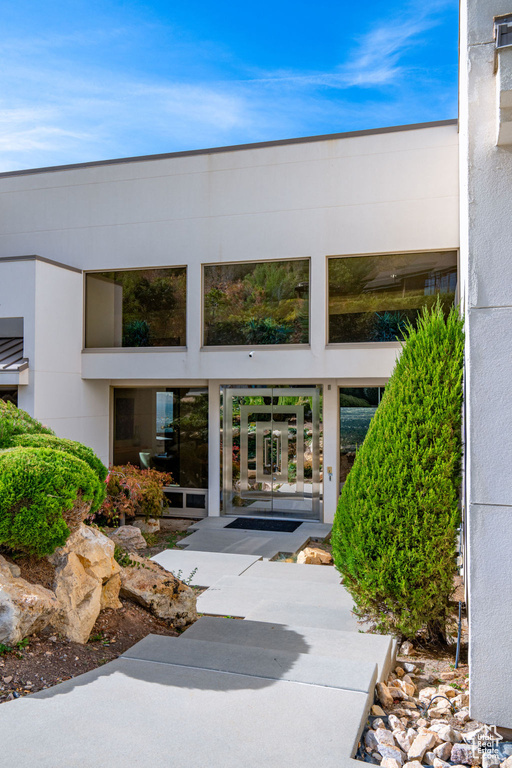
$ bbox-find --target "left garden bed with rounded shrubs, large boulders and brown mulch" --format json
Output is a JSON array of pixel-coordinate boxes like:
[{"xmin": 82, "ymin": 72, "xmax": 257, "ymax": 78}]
[{"xmin": 0, "ymin": 400, "xmax": 201, "ymax": 701}]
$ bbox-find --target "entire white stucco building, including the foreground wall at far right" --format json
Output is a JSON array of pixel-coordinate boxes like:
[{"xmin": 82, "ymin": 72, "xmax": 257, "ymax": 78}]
[{"xmin": 0, "ymin": 0, "xmax": 512, "ymax": 728}]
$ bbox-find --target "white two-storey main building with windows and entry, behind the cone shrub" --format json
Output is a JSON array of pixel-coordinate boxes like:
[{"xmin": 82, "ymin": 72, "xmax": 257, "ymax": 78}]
[{"xmin": 0, "ymin": 121, "xmax": 459, "ymax": 522}]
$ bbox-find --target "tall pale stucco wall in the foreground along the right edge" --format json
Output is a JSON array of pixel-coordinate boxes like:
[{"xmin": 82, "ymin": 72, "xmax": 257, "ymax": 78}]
[{"xmin": 460, "ymin": 0, "xmax": 512, "ymax": 728}]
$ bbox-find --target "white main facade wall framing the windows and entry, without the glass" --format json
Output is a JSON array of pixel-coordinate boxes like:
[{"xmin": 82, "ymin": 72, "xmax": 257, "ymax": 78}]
[{"xmin": 0, "ymin": 125, "xmax": 458, "ymax": 520}]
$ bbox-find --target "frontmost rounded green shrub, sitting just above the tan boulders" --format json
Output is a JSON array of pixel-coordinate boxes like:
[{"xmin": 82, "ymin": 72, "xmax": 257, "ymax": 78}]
[{"xmin": 0, "ymin": 447, "xmax": 100, "ymax": 556}]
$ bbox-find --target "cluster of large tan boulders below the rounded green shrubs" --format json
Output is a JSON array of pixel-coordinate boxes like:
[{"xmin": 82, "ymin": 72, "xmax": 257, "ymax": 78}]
[{"xmin": 0, "ymin": 523, "xmax": 197, "ymax": 646}]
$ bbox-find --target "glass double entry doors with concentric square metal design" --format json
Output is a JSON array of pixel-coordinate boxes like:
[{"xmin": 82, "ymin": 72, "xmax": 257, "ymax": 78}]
[{"xmin": 223, "ymin": 387, "xmax": 321, "ymax": 520}]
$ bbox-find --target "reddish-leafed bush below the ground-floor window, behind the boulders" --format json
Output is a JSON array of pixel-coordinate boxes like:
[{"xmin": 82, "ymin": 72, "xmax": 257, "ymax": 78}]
[{"xmin": 97, "ymin": 464, "xmax": 173, "ymax": 521}]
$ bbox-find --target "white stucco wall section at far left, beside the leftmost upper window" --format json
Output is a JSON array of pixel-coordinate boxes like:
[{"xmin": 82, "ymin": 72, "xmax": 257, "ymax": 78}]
[{"xmin": 0, "ymin": 258, "xmax": 109, "ymax": 461}]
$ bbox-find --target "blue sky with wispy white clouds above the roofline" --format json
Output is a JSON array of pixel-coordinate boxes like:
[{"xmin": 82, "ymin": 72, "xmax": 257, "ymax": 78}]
[{"xmin": 0, "ymin": 0, "xmax": 458, "ymax": 171}]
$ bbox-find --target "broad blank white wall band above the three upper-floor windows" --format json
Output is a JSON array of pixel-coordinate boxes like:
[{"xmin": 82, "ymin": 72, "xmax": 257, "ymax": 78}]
[{"xmin": 0, "ymin": 125, "xmax": 458, "ymax": 272}]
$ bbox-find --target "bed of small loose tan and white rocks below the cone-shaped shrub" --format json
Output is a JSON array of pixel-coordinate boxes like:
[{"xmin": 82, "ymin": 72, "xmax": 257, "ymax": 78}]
[{"xmin": 356, "ymin": 642, "xmax": 502, "ymax": 768}]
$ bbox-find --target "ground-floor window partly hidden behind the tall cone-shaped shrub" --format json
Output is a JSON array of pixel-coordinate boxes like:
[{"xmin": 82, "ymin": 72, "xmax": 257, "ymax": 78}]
[{"xmin": 340, "ymin": 387, "xmax": 384, "ymax": 486}]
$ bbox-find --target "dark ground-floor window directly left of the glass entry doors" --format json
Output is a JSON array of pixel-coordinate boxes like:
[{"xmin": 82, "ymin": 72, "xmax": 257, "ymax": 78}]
[{"xmin": 114, "ymin": 387, "xmax": 208, "ymax": 488}]
